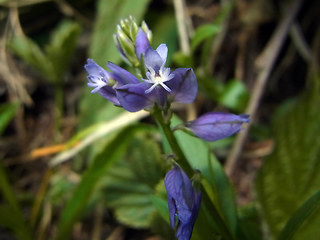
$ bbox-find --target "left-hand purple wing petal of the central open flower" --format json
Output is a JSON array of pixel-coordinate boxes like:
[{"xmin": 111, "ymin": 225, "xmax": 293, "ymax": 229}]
[{"xmin": 116, "ymin": 83, "xmax": 154, "ymax": 112}]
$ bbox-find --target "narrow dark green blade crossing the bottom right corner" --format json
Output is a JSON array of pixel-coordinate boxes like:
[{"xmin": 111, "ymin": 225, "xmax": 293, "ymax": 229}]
[{"xmin": 278, "ymin": 190, "xmax": 320, "ymax": 240}]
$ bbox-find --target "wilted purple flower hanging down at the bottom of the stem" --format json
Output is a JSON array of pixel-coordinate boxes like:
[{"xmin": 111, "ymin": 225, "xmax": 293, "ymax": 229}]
[{"xmin": 164, "ymin": 165, "xmax": 201, "ymax": 240}]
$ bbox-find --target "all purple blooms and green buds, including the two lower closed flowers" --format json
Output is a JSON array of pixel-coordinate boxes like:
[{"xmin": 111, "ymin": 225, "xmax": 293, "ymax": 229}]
[{"xmin": 84, "ymin": 18, "xmax": 249, "ymax": 240}]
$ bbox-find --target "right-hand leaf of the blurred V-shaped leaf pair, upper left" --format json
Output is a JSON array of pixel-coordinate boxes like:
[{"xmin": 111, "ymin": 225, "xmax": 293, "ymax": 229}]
[{"xmin": 46, "ymin": 21, "xmax": 80, "ymax": 83}]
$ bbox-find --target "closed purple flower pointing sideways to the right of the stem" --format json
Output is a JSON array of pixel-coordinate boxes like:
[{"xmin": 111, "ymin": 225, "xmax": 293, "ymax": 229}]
[{"xmin": 185, "ymin": 112, "xmax": 249, "ymax": 141}]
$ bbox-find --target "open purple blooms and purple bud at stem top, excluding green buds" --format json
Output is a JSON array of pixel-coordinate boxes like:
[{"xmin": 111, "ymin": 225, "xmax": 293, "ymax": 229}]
[{"xmin": 85, "ymin": 30, "xmax": 198, "ymax": 112}]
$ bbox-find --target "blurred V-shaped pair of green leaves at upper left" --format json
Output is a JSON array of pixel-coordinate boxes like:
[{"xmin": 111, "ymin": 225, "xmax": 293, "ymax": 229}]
[{"xmin": 9, "ymin": 21, "xmax": 81, "ymax": 86}]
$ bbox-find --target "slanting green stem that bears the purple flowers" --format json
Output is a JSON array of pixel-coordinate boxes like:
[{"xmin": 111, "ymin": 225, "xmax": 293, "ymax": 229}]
[{"xmin": 152, "ymin": 108, "xmax": 234, "ymax": 240}]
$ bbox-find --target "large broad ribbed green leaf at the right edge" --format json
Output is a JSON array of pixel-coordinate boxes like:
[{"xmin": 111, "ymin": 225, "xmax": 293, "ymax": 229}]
[{"xmin": 255, "ymin": 82, "xmax": 320, "ymax": 239}]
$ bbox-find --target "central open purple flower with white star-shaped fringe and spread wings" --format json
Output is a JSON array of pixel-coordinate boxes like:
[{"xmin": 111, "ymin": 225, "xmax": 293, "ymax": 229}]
[{"xmin": 117, "ymin": 44, "xmax": 198, "ymax": 112}]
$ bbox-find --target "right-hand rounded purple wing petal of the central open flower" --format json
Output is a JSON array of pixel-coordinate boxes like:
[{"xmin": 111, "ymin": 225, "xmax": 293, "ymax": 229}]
[{"xmin": 166, "ymin": 68, "xmax": 198, "ymax": 103}]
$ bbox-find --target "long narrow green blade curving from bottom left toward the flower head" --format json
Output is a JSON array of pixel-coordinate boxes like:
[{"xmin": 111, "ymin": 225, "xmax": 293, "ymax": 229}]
[{"xmin": 56, "ymin": 125, "xmax": 149, "ymax": 239}]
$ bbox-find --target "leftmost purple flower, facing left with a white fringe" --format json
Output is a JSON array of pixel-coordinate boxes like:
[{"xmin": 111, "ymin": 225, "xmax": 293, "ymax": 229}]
[{"xmin": 84, "ymin": 59, "xmax": 139, "ymax": 105}]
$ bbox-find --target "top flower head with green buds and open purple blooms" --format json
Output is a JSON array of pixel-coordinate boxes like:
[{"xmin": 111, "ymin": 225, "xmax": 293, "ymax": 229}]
[{"xmin": 86, "ymin": 19, "xmax": 198, "ymax": 112}]
